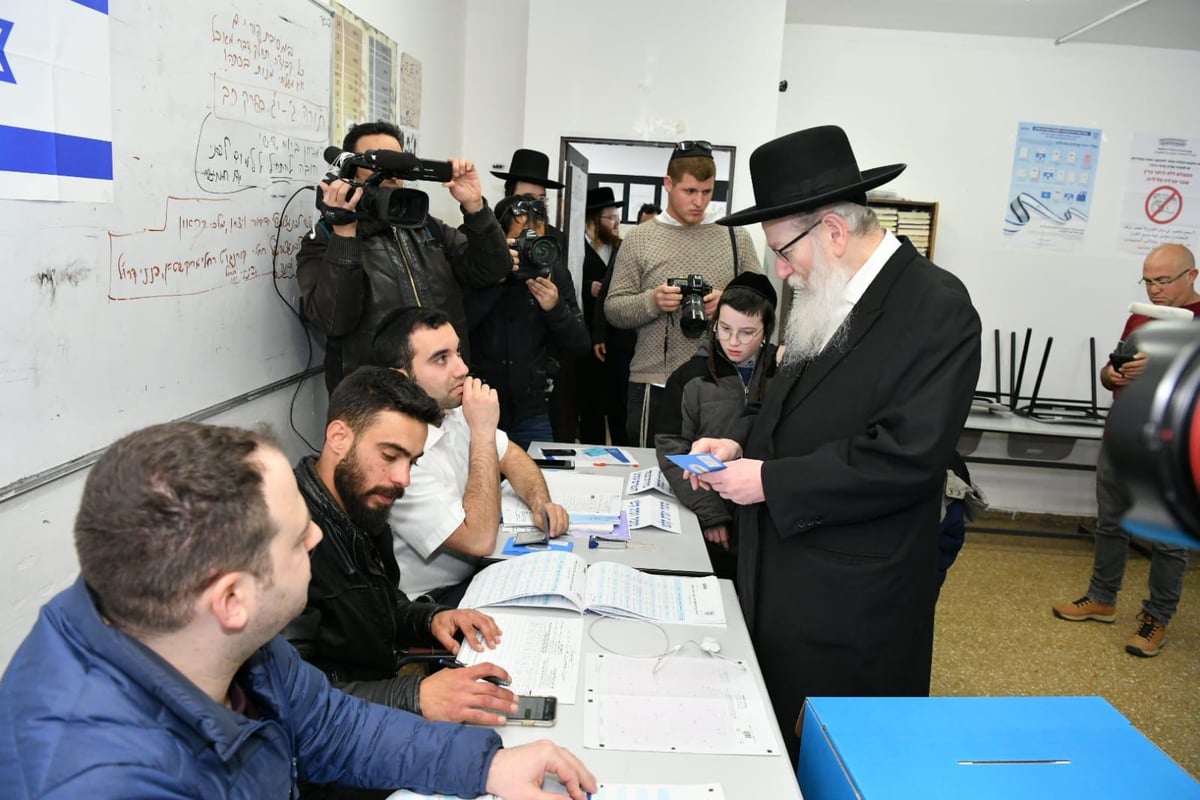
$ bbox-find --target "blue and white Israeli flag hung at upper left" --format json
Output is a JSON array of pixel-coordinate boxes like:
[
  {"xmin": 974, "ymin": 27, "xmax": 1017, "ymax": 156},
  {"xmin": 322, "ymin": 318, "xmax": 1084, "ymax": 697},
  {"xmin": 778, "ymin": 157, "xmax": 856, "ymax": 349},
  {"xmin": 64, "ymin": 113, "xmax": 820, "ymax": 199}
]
[{"xmin": 0, "ymin": 0, "xmax": 113, "ymax": 203}]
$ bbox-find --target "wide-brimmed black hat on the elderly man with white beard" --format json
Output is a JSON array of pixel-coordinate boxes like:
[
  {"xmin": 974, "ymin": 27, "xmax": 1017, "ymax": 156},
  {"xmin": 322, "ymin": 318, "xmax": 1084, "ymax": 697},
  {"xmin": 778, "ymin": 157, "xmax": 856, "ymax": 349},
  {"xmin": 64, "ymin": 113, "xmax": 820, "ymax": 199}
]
[{"xmin": 716, "ymin": 125, "xmax": 907, "ymax": 225}]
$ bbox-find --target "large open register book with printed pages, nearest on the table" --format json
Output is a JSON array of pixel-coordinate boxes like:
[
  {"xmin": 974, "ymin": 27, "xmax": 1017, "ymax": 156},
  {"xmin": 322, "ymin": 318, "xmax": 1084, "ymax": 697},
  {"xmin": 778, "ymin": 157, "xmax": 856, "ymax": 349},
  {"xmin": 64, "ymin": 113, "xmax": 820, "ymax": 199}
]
[{"xmin": 458, "ymin": 552, "xmax": 725, "ymax": 625}]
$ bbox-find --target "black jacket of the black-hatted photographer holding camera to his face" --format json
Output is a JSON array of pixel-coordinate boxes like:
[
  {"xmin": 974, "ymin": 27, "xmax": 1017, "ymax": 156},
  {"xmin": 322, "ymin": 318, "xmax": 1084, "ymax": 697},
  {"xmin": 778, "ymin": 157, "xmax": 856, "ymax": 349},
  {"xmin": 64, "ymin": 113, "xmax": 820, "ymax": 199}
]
[{"xmin": 467, "ymin": 264, "xmax": 592, "ymax": 420}]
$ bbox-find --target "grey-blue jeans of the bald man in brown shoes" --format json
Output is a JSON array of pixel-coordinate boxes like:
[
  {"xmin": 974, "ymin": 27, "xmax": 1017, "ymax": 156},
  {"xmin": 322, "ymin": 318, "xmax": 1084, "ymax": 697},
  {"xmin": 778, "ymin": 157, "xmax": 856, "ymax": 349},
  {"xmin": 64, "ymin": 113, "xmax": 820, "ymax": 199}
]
[{"xmin": 1087, "ymin": 441, "xmax": 1188, "ymax": 625}]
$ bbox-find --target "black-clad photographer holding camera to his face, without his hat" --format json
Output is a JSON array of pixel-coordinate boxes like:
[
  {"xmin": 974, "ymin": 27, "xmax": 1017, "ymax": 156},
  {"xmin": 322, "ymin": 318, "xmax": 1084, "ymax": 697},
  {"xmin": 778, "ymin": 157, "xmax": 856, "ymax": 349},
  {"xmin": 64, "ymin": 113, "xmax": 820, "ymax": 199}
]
[{"xmin": 467, "ymin": 194, "xmax": 592, "ymax": 449}]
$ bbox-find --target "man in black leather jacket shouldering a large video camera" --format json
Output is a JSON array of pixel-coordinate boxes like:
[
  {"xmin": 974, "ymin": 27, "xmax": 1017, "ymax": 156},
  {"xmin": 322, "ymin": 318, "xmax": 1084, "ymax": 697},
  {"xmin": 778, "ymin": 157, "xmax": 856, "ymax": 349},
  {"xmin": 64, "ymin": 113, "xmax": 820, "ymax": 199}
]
[{"xmin": 296, "ymin": 121, "xmax": 512, "ymax": 391}]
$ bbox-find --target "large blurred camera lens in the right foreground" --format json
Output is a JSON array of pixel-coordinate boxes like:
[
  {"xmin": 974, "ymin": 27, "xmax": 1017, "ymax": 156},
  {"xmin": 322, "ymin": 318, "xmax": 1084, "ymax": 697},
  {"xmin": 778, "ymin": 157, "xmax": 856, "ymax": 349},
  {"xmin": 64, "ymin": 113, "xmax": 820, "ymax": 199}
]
[{"xmin": 1104, "ymin": 321, "xmax": 1200, "ymax": 549}]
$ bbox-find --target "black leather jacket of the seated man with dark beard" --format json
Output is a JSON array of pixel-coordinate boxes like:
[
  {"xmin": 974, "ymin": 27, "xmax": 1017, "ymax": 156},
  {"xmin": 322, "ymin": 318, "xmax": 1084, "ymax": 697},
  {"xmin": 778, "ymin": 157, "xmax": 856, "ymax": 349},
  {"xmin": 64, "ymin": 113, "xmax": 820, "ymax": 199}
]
[{"xmin": 283, "ymin": 456, "xmax": 445, "ymax": 714}]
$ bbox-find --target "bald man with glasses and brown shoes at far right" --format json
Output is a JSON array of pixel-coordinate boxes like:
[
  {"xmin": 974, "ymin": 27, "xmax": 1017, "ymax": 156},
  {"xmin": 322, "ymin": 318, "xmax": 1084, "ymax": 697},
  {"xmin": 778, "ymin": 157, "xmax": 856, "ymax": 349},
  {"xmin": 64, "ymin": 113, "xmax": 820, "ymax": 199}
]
[{"xmin": 1052, "ymin": 245, "xmax": 1200, "ymax": 658}]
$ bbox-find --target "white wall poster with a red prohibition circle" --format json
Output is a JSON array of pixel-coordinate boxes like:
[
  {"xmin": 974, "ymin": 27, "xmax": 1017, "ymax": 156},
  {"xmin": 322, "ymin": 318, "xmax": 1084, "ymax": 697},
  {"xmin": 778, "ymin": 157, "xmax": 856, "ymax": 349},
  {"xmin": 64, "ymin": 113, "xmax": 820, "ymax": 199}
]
[{"xmin": 1118, "ymin": 133, "xmax": 1200, "ymax": 253}]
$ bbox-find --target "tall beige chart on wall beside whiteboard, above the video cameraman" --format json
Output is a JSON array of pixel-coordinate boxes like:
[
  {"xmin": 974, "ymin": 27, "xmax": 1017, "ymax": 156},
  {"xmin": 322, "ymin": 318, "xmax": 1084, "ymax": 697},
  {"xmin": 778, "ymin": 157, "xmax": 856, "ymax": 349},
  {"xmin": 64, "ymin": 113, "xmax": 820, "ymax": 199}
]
[{"xmin": 330, "ymin": 2, "xmax": 400, "ymax": 143}]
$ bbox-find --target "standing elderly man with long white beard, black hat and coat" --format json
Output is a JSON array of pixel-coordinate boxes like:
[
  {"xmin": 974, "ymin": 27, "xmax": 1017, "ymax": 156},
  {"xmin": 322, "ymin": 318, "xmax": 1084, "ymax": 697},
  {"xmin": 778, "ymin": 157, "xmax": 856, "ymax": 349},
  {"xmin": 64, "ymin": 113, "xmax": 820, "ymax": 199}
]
[{"xmin": 694, "ymin": 126, "xmax": 979, "ymax": 759}]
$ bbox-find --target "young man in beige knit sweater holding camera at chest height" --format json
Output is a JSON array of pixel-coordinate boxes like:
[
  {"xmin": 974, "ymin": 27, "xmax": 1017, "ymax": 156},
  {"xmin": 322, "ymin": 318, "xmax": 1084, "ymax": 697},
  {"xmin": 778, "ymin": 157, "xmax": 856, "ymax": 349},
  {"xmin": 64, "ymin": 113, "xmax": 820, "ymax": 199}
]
[{"xmin": 604, "ymin": 140, "xmax": 762, "ymax": 447}]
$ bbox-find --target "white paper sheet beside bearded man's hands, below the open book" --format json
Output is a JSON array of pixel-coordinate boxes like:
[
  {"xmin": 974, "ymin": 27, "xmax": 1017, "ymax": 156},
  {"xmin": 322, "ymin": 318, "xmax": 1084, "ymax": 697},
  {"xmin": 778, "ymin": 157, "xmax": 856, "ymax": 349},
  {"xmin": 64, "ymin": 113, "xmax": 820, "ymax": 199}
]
[{"xmin": 458, "ymin": 613, "xmax": 583, "ymax": 704}]
